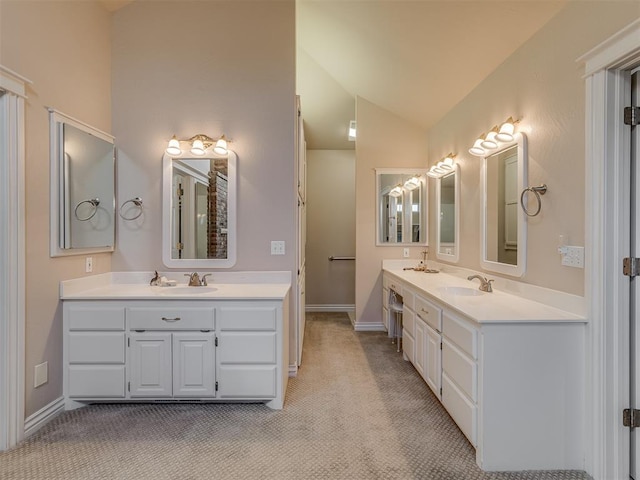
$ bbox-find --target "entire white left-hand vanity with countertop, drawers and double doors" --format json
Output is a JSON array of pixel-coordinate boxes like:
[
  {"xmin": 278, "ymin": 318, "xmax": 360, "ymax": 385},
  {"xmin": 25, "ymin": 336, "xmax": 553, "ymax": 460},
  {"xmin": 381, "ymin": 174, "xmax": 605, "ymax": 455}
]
[{"xmin": 61, "ymin": 272, "xmax": 290, "ymax": 409}]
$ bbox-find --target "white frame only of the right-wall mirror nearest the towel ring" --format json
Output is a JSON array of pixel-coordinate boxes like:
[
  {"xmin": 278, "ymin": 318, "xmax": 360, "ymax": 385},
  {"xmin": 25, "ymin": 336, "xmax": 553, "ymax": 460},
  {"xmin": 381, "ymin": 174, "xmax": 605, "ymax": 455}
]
[{"xmin": 480, "ymin": 133, "xmax": 528, "ymax": 277}]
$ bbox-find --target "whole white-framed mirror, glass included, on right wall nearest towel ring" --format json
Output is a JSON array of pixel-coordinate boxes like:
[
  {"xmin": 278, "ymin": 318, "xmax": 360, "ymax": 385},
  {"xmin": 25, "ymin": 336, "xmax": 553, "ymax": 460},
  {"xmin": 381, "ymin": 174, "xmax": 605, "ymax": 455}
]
[{"xmin": 480, "ymin": 133, "xmax": 527, "ymax": 277}]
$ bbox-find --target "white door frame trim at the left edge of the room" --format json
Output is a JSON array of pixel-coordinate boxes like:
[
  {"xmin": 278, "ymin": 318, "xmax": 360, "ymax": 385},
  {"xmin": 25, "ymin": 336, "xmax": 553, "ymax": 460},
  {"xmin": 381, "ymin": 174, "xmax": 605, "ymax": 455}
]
[{"xmin": 0, "ymin": 65, "xmax": 31, "ymax": 451}]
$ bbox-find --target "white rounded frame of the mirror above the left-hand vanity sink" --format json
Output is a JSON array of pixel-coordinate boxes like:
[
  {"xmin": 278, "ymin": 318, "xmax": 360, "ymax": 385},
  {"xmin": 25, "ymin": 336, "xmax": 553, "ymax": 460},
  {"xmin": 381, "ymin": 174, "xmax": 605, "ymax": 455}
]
[{"xmin": 162, "ymin": 147, "xmax": 238, "ymax": 269}]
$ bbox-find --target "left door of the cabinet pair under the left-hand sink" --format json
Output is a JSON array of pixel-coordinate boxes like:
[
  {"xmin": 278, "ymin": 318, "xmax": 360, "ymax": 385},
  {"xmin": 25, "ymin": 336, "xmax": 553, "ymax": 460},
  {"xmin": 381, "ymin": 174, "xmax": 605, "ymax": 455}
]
[{"xmin": 129, "ymin": 333, "xmax": 173, "ymax": 397}]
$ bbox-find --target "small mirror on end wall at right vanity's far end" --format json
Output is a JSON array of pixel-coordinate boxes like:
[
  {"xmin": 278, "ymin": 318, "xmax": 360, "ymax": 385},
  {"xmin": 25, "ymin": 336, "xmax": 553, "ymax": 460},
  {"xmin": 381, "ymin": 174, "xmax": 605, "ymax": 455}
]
[{"xmin": 376, "ymin": 168, "xmax": 428, "ymax": 246}]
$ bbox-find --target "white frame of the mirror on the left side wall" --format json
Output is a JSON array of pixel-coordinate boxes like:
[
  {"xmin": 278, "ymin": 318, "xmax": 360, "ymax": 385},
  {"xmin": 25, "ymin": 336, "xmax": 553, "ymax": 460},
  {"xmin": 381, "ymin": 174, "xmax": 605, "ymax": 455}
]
[{"xmin": 48, "ymin": 108, "xmax": 117, "ymax": 257}]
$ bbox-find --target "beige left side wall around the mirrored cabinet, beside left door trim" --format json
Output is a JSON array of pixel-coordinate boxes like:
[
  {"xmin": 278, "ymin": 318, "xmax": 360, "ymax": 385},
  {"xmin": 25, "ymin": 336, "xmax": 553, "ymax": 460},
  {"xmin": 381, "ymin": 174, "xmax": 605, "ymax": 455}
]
[{"xmin": 0, "ymin": 0, "xmax": 111, "ymax": 416}]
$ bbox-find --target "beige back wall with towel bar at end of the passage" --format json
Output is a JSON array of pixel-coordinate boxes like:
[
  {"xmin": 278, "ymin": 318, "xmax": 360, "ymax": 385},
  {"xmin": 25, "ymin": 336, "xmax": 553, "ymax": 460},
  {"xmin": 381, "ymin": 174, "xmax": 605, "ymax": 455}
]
[{"xmin": 305, "ymin": 150, "xmax": 356, "ymax": 306}]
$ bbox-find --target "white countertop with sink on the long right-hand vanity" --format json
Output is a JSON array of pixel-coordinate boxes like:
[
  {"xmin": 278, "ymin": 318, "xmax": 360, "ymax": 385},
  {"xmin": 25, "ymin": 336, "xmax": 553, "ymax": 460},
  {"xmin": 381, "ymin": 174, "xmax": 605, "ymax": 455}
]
[{"xmin": 383, "ymin": 267, "xmax": 587, "ymax": 324}]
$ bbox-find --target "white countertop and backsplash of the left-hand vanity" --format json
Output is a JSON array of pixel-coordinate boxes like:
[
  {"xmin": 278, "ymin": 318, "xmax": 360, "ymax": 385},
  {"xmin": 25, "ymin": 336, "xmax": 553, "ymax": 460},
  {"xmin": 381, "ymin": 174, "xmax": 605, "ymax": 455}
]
[{"xmin": 60, "ymin": 272, "xmax": 291, "ymax": 300}]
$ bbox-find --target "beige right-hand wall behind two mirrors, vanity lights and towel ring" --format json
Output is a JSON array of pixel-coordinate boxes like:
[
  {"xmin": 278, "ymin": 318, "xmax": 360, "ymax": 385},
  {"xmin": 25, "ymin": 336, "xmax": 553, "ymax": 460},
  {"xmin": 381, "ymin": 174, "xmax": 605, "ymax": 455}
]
[{"xmin": 428, "ymin": 2, "xmax": 640, "ymax": 295}]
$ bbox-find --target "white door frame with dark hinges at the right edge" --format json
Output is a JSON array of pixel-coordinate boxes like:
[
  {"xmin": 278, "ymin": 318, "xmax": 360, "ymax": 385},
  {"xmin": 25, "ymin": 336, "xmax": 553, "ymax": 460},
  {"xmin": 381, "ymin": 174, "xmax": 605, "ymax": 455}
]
[{"xmin": 577, "ymin": 20, "xmax": 640, "ymax": 480}]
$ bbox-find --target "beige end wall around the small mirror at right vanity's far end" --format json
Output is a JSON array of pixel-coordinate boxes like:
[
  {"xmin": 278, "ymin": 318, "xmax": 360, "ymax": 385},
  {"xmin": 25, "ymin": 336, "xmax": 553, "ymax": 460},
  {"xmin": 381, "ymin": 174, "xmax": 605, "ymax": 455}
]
[{"xmin": 356, "ymin": 97, "xmax": 432, "ymax": 324}]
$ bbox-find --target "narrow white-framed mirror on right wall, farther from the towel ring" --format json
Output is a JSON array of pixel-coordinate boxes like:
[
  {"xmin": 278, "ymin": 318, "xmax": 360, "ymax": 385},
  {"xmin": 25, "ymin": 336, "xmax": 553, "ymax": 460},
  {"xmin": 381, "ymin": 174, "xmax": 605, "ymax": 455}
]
[{"xmin": 436, "ymin": 164, "xmax": 460, "ymax": 263}]
